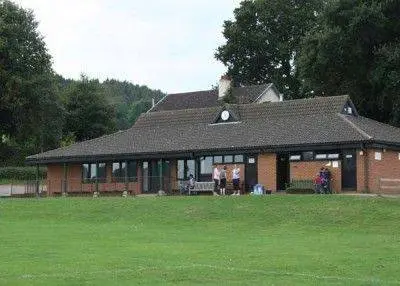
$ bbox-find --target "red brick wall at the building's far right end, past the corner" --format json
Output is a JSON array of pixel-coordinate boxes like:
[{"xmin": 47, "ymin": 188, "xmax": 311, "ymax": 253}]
[{"xmin": 367, "ymin": 149, "xmax": 400, "ymax": 194}]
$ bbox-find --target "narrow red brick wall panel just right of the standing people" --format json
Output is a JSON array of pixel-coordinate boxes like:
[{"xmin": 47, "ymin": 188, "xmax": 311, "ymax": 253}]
[{"xmin": 257, "ymin": 153, "xmax": 276, "ymax": 192}]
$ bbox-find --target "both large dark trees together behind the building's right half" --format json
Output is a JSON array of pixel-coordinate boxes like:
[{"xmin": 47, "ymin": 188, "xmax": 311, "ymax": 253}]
[{"xmin": 215, "ymin": 0, "xmax": 400, "ymax": 127}]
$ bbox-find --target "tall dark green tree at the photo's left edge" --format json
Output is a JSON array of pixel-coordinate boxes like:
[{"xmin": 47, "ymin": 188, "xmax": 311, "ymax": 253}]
[{"xmin": 0, "ymin": 1, "xmax": 62, "ymax": 161}]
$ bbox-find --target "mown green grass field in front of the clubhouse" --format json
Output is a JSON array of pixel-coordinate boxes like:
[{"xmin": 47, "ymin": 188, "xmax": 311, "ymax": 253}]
[{"xmin": 0, "ymin": 195, "xmax": 400, "ymax": 285}]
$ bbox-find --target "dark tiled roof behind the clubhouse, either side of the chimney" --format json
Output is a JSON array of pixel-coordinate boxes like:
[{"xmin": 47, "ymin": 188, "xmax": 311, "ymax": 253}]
[{"xmin": 150, "ymin": 84, "xmax": 271, "ymax": 112}]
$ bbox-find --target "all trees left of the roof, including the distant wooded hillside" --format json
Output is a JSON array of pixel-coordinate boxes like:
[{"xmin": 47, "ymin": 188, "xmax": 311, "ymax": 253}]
[{"xmin": 0, "ymin": 1, "xmax": 164, "ymax": 166}]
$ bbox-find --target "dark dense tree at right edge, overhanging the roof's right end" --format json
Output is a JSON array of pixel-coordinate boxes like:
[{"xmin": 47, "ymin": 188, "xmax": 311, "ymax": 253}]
[{"xmin": 298, "ymin": 0, "xmax": 400, "ymax": 126}]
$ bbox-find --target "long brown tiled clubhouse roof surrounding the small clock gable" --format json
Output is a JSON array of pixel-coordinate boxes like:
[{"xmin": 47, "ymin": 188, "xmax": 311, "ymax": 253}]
[{"xmin": 28, "ymin": 96, "xmax": 400, "ymax": 161}]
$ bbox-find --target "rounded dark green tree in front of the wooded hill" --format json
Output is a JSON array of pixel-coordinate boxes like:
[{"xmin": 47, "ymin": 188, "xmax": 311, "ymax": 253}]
[{"xmin": 64, "ymin": 75, "xmax": 115, "ymax": 141}]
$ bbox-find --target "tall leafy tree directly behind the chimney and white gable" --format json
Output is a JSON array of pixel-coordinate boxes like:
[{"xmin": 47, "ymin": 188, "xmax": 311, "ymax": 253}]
[{"xmin": 215, "ymin": 0, "xmax": 324, "ymax": 98}]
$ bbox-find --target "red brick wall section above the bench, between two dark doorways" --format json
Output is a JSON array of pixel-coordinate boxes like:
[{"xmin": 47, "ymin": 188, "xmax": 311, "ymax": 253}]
[{"xmin": 290, "ymin": 161, "xmax": 342, "ymax": 192}]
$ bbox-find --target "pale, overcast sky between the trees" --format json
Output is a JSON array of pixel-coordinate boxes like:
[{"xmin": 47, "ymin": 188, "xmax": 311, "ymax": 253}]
[{"xmin": 14, "ymin": 0, "xmax": 241, "ymax": 93}]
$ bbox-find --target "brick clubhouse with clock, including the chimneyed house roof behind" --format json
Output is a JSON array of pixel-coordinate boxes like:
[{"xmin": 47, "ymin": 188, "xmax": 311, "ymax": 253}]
[{"xmin": 26, "ymin": 77, "xmax": 400, "ymax": 194}]
